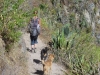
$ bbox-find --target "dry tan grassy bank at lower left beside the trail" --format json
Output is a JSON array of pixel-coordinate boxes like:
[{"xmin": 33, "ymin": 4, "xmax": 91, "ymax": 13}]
[{"xmin": 0, "ymin": 37, "xmax": 29, "ymax": 75}]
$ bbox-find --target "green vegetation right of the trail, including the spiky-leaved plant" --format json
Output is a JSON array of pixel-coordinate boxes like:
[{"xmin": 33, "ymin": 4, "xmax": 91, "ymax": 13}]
[{"xmin": 53, "ymin": 25, "xmax": 100, "ymax": 75}]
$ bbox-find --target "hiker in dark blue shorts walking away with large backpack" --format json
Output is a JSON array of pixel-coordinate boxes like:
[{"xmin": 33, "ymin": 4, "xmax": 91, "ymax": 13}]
[{"xmin": 29, "ymin": 11, "xmax": 40, "ymax": 53}]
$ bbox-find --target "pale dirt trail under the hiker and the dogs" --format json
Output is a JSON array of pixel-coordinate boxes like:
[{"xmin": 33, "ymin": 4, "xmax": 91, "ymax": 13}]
[{"xmin": 23, "ymin": 33, "xmax": 64, "ymax": 75}]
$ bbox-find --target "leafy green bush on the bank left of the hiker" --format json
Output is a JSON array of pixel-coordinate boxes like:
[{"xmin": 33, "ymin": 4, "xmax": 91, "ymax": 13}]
[{"xmin": 0, "ymin": 0, "xmax": 31, "ymax": 52}]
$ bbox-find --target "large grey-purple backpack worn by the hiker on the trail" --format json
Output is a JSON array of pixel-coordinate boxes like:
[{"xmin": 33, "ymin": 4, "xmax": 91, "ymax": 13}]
[{"xmin": 30, "ymin": 18, "xmax": 40, "ymax": 36}]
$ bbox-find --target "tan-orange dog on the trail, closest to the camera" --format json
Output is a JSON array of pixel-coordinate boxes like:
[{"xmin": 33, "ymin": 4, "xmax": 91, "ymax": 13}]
[{"xmin": 42, "ymin": 54, "xmax": 54, "ymax": 75}]
